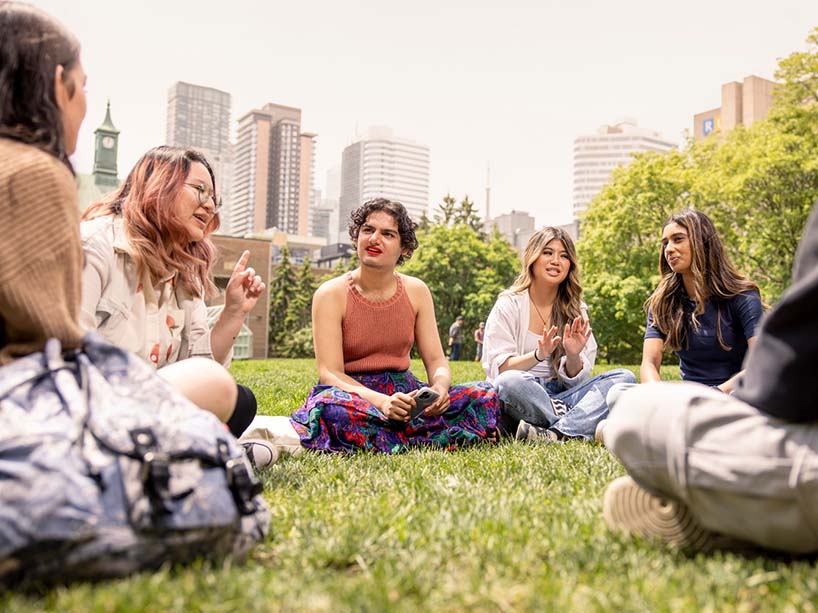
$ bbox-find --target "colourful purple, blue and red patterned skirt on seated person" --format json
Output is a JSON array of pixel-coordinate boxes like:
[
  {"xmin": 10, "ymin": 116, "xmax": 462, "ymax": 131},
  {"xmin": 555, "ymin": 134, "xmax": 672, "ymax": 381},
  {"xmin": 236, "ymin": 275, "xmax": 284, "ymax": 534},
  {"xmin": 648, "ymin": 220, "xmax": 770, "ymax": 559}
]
[{"xmin": 290, "ymin": 370, "xmax": 500, "ymax": 453}]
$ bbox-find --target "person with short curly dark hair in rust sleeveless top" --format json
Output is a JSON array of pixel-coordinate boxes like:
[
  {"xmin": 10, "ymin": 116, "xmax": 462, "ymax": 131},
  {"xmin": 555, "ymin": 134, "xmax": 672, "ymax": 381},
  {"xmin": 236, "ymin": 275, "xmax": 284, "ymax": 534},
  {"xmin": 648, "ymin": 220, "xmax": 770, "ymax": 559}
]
[{"xmin": 276, "ymin": 198, "xmax": 500, "ymax": 453}]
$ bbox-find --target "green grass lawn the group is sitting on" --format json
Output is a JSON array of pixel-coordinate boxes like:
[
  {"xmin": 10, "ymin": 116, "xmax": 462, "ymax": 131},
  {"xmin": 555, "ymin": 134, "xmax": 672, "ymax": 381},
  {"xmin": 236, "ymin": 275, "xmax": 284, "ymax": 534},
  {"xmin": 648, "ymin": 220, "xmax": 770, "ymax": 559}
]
[{"xmin": 0, "ymin": 360, "xmax": 818, "ymax": 613}]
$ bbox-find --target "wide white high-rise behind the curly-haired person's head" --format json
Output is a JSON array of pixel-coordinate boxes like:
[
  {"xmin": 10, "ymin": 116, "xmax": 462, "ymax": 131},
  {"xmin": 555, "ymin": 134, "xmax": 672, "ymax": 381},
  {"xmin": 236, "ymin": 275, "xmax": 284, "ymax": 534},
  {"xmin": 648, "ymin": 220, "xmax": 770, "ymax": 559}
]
[{"xmin": 338, "ymin": 128, "xmax": 430, "ymax": 241}]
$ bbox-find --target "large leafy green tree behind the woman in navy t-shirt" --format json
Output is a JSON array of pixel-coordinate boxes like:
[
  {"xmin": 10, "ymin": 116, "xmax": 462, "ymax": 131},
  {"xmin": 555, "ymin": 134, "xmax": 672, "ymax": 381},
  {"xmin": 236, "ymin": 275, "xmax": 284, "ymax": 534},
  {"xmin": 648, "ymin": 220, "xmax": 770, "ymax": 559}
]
[{"xmin": 578, "ymin": 29, "xmax": 818, "ymax": 362}]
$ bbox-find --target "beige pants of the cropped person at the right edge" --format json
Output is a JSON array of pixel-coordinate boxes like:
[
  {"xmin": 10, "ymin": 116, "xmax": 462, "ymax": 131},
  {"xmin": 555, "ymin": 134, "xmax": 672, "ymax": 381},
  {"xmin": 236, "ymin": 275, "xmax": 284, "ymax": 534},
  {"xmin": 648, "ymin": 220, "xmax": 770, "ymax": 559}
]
[{"xmin": 604, "ymin": 383, "xmax": 818, "ymax": 553}]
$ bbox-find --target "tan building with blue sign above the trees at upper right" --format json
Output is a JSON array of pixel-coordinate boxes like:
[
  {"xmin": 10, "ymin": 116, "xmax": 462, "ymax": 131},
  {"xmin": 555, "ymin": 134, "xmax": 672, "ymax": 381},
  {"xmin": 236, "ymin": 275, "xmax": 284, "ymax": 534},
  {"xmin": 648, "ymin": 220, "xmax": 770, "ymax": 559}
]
[{"xmin": 693, "ymin": 75, "xmax": 775, "ymax": 140}]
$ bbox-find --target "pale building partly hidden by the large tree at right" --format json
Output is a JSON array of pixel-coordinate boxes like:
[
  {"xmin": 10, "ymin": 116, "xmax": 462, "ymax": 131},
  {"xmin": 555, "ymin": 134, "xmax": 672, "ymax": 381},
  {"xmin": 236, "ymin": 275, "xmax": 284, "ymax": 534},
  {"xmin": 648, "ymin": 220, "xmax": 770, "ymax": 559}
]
[{"xmin": 573, "ymin": 119, "xmax": 676, "ymax": 219}]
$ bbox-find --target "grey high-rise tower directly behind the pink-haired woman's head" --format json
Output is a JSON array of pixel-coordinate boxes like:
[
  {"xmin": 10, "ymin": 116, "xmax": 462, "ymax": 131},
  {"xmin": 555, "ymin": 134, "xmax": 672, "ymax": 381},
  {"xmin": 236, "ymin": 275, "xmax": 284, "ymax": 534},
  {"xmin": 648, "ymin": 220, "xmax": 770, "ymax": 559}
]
[{"xmin": 165, "ymin": 81, "xmax": 233, "ymax": 234}]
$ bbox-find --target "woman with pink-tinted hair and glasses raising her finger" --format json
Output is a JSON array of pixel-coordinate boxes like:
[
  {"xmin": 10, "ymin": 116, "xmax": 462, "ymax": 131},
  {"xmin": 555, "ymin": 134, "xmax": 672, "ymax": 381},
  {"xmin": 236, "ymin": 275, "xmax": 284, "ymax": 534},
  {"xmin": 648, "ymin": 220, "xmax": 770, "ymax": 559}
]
[{"xmin": 80, "ymin": 147, "xmax": 264, "ymax": 436}]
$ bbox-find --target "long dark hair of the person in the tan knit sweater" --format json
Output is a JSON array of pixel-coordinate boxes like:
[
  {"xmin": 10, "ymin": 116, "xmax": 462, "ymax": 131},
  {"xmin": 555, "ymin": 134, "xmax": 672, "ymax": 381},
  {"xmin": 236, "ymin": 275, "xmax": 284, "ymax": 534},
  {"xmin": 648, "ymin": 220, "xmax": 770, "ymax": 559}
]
[{"xmin": 0, "ymin": 0, "xmax": 80, "ymax": 172}]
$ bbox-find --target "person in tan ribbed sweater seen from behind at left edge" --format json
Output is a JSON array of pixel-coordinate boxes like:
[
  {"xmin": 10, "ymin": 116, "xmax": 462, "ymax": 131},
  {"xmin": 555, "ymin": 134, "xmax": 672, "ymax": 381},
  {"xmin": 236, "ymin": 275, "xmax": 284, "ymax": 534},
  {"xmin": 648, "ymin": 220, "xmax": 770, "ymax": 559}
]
[{"xmin": 0, "ymin": 2, "xmax": 86, "ymax": 364}]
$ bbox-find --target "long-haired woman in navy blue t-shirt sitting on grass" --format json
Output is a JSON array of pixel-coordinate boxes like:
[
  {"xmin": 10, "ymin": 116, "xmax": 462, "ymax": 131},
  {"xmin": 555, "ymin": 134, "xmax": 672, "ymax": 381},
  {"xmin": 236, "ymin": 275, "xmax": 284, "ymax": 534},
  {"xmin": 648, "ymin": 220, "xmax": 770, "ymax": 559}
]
[{"xmin": 639, "ymin": 209, "xmax": 764, "ymax": 393}]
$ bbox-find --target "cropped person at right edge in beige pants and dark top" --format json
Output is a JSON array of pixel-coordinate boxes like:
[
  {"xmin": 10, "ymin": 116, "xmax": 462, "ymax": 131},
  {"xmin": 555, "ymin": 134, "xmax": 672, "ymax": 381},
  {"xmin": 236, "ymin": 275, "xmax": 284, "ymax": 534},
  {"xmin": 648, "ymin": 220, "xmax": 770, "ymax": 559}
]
[{"xmin": 603, "ymin": 202, "xmax": 818, "ymax": 554}]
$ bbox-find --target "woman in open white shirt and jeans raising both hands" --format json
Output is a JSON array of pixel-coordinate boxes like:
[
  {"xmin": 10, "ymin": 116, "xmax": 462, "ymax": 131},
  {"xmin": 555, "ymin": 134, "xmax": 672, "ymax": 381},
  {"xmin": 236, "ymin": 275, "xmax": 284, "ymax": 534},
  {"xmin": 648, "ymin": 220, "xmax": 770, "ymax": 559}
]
[{"xmin": 483, "ymin": 227, "xmax": 636, "ymax": 442}]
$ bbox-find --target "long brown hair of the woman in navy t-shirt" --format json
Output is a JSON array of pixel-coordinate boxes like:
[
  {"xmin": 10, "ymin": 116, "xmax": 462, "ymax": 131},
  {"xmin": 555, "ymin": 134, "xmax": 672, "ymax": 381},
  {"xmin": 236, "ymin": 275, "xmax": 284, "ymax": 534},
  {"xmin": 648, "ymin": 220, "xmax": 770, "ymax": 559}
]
[{"xmin": 645, "ymin": 209, "xmax": 759, "ymax": 351}]
